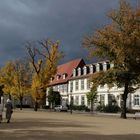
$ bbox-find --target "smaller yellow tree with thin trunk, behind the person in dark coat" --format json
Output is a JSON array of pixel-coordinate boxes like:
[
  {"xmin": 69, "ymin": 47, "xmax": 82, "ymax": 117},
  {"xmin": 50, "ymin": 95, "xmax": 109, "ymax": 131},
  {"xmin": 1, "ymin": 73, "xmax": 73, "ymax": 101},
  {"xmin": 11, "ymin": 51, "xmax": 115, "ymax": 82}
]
[{"xmin": 11, "ymin": 59, "xmax": 32, "ymax": 110}]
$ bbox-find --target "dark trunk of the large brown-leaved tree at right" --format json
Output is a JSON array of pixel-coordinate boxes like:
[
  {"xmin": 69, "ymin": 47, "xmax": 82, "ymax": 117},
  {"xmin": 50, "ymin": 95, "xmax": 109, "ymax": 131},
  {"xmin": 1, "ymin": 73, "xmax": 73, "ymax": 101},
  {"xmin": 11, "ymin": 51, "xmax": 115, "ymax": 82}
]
[{"xmin": 121, "ymin": 82, "xmax": 128, "ymax": 119}]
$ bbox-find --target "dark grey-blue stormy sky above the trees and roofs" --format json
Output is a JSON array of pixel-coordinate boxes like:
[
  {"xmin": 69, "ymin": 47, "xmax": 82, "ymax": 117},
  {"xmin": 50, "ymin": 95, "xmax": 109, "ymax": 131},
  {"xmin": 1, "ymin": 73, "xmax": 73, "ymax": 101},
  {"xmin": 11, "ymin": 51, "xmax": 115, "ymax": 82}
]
[{"xmin": 0, "ymin": 0, "xmax": 140, "ymax": 66}]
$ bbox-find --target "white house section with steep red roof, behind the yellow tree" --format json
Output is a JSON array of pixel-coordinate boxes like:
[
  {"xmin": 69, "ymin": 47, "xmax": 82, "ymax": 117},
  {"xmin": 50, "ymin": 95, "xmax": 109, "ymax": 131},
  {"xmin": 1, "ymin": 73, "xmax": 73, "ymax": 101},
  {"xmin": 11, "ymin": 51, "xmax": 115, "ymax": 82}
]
[{"xmin": 46, "ymin": 59, "xmax": 85, "ymax": 105}]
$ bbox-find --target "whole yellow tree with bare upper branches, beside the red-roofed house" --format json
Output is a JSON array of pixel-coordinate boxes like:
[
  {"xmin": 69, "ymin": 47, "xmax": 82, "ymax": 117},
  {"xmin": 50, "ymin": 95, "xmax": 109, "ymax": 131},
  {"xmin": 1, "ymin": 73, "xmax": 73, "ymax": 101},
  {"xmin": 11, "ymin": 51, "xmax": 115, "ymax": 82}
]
[{"xmin": 26, "ymin": 40, "xmax": 62, "ymax": 111}]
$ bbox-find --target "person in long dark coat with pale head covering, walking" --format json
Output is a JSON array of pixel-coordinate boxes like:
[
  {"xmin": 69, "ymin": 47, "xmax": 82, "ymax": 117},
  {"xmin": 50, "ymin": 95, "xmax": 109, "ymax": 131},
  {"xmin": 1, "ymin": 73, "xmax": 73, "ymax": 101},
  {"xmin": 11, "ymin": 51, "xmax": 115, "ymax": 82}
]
[{"xmin": 5, "ymin": 99, "xmax": 13, "ymax": 123}]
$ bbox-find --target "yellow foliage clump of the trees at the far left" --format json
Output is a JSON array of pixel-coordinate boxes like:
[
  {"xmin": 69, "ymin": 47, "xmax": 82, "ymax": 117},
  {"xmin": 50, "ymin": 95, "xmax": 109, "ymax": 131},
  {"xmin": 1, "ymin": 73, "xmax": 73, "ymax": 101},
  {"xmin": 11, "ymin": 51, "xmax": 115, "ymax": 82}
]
[{"xmin": 0, "ymin": 62, "xmax": 30, "ymax": 99}]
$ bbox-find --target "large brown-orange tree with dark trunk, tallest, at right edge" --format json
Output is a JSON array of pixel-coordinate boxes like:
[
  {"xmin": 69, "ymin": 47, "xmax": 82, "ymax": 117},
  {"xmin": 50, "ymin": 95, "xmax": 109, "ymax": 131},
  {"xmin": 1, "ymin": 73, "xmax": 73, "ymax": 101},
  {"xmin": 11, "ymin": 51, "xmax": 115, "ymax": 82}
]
[{"xmin": 83, "ymin": 0, "xmax": 140, "ymax": 118}]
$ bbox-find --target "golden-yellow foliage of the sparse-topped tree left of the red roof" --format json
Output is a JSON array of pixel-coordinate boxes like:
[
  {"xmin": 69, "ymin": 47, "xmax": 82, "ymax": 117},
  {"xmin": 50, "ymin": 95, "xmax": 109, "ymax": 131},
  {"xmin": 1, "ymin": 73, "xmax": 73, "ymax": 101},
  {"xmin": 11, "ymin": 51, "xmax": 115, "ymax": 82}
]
[{"xmin": 28, "ymin": 40, "xmax": 62, "ymax": 102}]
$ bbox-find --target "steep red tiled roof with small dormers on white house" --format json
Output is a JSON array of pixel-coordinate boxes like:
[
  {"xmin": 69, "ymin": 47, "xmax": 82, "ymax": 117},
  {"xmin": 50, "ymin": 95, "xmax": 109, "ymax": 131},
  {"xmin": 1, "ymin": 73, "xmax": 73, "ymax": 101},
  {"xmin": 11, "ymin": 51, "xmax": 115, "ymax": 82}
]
[{"xmin": 49, "ymin": 59, "xmax": 85, "ymax": 86}]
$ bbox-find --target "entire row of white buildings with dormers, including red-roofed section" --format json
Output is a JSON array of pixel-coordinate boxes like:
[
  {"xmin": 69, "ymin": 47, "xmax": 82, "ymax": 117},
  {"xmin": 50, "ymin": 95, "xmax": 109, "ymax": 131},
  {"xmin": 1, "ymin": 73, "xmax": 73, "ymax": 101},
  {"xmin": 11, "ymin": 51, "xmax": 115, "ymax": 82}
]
[{"xmin": 46, "ymin": 59, "xmax": 140, "ymax": 110}]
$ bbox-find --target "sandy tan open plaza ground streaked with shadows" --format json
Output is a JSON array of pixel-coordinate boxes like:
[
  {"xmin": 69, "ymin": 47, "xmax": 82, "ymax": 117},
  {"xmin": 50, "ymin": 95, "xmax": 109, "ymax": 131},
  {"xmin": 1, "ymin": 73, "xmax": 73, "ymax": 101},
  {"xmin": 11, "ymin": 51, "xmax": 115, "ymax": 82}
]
[{"xmin": 0, "ymin": 110, "xmax": 140, "ymax": 140}]
